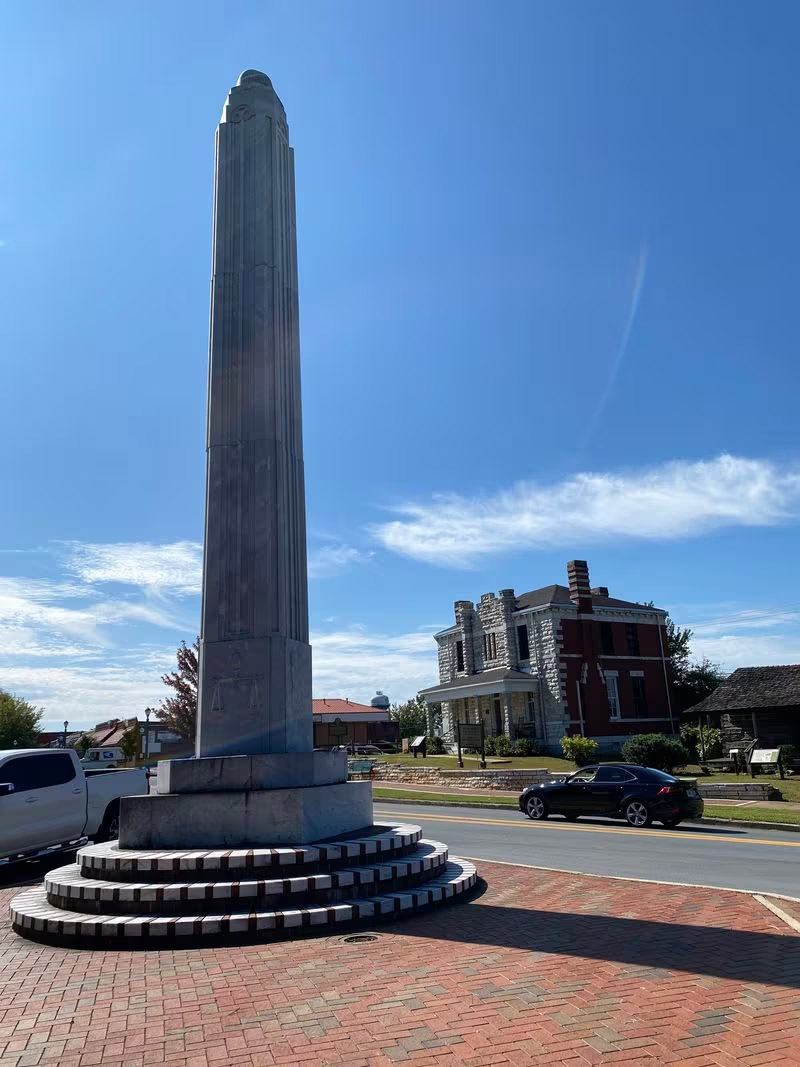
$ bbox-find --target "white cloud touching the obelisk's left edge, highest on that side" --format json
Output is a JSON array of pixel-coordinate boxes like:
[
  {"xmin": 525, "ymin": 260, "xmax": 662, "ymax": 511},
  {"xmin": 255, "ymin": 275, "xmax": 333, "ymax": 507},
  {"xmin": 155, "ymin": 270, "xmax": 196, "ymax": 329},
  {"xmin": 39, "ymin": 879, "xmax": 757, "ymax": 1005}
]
[{"xmin": 65, "ymin": 541, "xmax": 203, "ymax": 596}]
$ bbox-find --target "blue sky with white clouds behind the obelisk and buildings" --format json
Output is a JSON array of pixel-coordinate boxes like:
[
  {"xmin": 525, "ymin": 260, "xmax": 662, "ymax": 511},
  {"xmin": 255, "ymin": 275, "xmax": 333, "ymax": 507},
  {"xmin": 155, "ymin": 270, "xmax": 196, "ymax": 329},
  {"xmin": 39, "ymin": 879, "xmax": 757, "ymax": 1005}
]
[{"xmin": 0, "ymin": 0, "xmax": 800, "ymax": 726}]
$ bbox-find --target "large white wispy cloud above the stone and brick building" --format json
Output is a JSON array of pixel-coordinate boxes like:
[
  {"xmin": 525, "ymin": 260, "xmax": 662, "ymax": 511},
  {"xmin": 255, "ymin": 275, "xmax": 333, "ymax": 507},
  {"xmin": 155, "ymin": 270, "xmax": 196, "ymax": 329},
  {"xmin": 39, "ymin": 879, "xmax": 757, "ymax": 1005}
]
[{"xmin": 371, "ymin": 455, "xmax": 800, "ymax": 568}]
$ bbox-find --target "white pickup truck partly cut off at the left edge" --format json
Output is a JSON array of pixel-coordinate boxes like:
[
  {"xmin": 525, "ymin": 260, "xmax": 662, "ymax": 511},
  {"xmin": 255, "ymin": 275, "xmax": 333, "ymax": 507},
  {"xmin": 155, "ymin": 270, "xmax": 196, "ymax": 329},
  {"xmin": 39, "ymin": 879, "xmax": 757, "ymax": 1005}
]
[{"xmin": 0, "ymin": 748, "xmax": 147, "ymax": 865}]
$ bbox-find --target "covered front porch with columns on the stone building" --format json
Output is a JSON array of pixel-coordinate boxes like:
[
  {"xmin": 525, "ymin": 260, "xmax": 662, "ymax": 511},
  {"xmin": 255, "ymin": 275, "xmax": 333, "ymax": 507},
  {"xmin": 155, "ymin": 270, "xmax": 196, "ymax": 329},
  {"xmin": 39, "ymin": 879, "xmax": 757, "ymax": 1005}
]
[{"xmin": 419, "ymin": 667, "xmax": 544, "ymax": 742}]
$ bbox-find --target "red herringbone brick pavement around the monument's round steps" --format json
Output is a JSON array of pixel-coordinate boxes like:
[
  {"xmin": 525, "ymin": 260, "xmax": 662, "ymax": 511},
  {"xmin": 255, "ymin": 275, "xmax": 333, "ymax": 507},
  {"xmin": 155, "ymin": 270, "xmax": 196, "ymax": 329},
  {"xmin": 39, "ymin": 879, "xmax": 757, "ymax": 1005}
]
[{"xmin": 0, "ymin": 863, "xmax": 800, "ymax": 1067}]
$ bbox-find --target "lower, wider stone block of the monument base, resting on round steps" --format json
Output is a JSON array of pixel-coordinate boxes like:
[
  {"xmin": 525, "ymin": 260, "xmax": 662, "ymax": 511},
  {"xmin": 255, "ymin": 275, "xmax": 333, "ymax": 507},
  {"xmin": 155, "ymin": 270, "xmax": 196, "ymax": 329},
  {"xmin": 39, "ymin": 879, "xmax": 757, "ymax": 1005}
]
[{"xmin": 119, "ymin": 782, "xmax": 372, "ymax": 848}]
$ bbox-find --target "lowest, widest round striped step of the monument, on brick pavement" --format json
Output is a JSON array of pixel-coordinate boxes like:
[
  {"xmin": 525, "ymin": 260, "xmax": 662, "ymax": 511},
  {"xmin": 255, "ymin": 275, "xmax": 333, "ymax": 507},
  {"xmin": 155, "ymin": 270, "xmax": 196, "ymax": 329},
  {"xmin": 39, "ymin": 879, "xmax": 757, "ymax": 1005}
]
[{"xmin": 11, "ymin": 859, "xmax": 477, "ymax": 947}]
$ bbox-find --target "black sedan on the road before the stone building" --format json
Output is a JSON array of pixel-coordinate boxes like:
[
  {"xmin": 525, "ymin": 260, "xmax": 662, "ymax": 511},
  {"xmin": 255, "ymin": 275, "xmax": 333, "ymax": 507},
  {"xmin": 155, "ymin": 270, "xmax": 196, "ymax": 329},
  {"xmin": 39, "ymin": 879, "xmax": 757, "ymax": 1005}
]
[{"xmin": 519, "ymin": 763, "xmax": 703, "ymax": 827}]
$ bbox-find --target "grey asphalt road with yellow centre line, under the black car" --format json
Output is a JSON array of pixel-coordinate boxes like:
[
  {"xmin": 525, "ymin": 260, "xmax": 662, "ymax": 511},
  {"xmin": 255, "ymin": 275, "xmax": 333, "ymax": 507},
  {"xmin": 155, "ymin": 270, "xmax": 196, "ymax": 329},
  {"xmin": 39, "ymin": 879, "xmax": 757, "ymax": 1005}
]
[{"xmin": 375, "ymin": 800, "xmax": 800, "ymax": 897}]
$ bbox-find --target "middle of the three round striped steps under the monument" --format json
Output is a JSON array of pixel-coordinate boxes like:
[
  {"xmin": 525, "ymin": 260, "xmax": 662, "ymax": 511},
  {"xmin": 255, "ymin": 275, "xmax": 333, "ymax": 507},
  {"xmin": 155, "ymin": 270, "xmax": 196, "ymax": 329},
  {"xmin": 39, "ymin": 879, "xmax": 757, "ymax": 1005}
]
[{"xmin": 45, "ymin": 841, "xmax": 448, "ymax": 915}]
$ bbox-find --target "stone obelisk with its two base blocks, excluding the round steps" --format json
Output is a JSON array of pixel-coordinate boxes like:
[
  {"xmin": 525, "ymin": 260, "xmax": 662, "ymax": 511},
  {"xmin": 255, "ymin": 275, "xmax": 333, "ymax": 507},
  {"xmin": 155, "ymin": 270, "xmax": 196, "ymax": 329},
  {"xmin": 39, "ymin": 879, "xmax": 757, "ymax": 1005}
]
[{"xmin": 115, "ymin": 70, "xmax": 372, "ymax": 848}]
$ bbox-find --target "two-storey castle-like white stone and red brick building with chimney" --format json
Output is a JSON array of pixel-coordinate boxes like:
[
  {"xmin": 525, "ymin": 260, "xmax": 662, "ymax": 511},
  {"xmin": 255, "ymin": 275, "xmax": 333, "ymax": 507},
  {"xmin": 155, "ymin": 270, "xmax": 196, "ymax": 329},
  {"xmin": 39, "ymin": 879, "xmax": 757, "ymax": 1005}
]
[{"xmin": 420, "ymin": 560, "xmax": 674, "ymax": 753}]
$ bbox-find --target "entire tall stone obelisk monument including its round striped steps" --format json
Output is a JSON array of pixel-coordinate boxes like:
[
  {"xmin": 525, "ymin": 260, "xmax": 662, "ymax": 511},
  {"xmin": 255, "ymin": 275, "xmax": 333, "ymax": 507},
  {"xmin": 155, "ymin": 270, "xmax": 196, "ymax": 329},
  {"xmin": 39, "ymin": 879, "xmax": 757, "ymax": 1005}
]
[{"xmin": 10, "ymin": 70, "xmax": 477, "ymax": 949}]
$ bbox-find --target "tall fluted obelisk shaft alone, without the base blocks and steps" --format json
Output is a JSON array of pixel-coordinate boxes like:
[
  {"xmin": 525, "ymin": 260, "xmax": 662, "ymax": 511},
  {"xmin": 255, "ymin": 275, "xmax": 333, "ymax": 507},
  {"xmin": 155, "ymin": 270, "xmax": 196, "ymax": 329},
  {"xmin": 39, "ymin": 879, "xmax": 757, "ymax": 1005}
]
[{"xmin": 197, "ymin": 70, "xmax": 314, "ymax": 757}]
